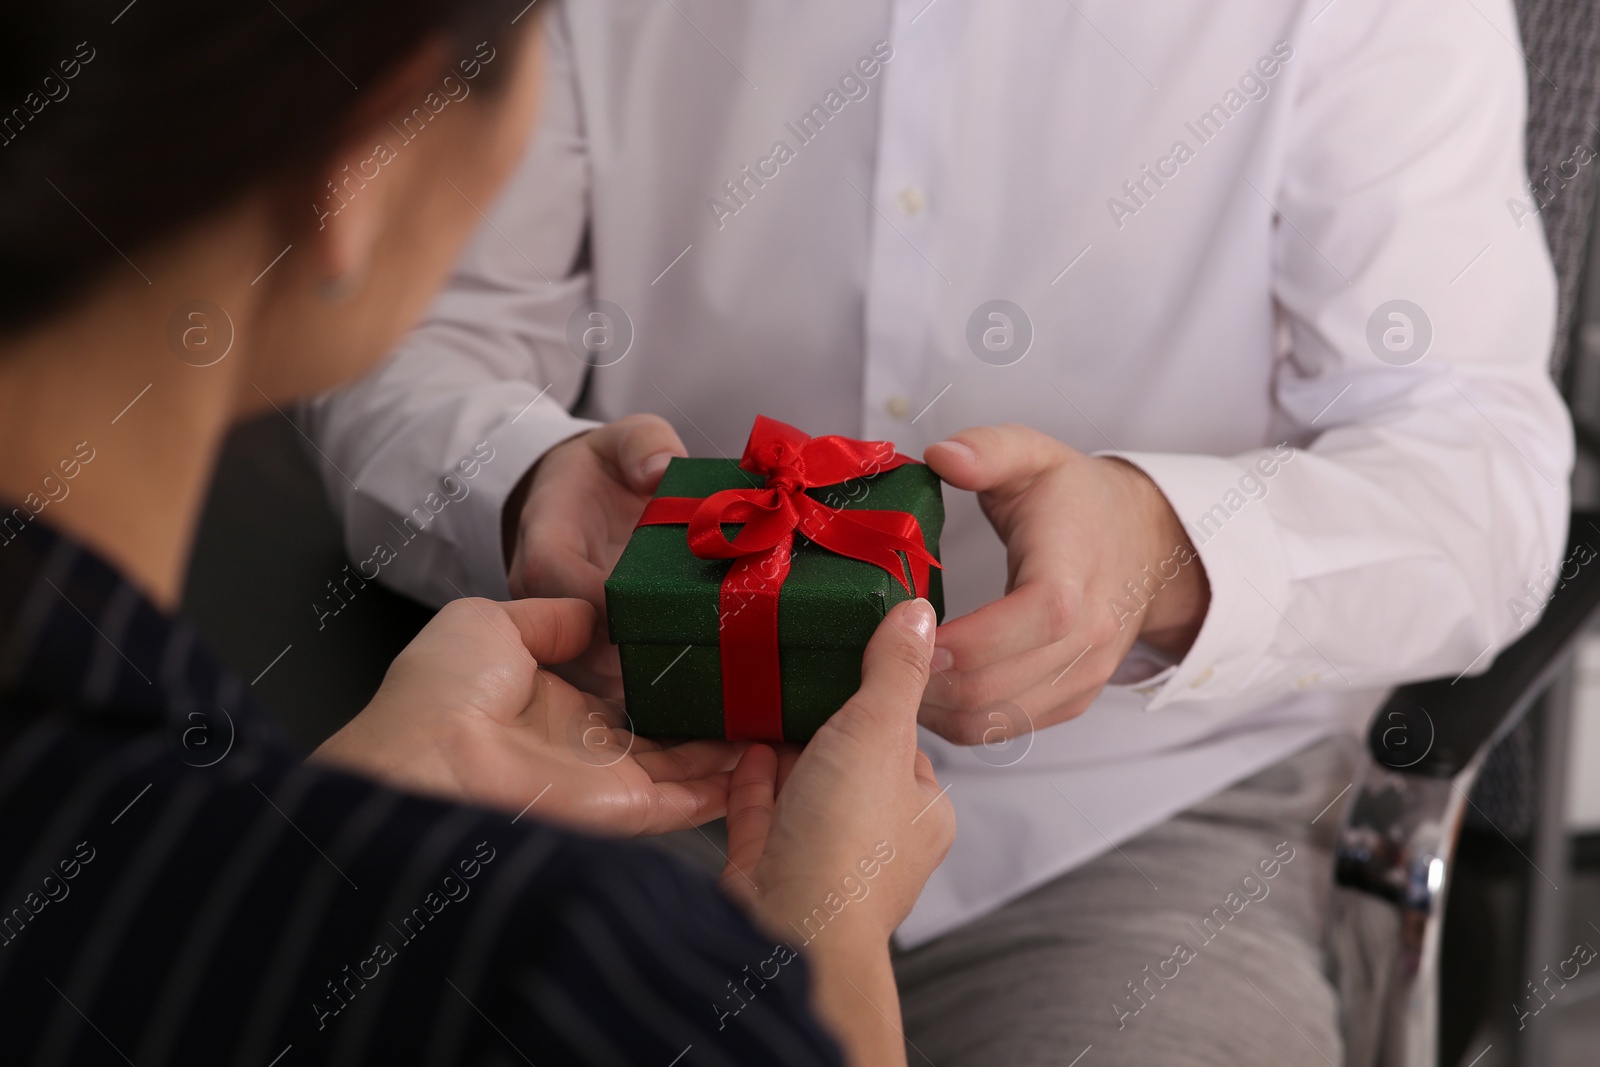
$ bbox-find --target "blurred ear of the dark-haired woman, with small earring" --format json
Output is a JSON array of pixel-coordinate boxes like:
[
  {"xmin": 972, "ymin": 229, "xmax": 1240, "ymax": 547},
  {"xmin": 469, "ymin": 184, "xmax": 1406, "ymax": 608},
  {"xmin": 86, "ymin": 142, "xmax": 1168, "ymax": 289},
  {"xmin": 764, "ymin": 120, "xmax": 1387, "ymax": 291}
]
[{"xmin": 304, "ymin": 40, "xmax": 448, "ymax": 304}]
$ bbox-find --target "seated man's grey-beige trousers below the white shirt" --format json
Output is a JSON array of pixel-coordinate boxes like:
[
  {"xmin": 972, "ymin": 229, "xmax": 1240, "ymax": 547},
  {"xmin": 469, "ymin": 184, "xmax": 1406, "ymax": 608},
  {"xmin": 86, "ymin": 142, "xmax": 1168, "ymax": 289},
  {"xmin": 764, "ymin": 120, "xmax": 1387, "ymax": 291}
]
[{"xmin": 643, "ymin": 737, "xmax": 1357, "ymax": 1067}]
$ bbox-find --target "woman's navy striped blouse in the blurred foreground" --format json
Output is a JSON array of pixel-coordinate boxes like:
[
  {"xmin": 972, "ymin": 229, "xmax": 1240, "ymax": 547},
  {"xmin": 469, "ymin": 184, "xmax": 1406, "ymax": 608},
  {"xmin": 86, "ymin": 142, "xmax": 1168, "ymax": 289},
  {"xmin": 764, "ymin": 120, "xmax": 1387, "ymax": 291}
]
[{"xmin": 0, "ymin": 511, "xmax": 840, "ymax": 1067}]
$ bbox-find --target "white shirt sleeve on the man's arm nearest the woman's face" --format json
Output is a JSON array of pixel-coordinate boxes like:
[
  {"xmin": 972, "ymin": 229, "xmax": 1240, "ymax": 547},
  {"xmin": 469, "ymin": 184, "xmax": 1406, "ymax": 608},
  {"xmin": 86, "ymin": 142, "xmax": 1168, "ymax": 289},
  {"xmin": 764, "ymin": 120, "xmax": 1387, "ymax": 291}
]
[{"xmin": 301, "ymin": 11, "xmax": 594, "ymax": 605}]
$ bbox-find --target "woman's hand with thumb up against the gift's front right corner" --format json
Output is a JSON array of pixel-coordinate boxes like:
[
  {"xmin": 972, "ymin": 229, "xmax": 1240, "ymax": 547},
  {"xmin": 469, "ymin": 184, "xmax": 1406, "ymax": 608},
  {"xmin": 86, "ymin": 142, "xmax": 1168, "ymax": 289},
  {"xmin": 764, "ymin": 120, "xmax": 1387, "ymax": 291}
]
[{"xmin": 722, "ymin": 600, "xmax": 955, "ymax": 1067}]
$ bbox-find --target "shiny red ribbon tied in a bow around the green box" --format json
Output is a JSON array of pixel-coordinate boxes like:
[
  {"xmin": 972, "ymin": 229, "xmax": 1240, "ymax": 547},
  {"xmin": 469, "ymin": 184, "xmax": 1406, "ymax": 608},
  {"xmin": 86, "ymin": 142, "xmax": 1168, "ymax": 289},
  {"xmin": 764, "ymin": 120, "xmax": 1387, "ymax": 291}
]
[{"xmin": 638, "ymin": 416, "xmax": 939, "ymax": 741}]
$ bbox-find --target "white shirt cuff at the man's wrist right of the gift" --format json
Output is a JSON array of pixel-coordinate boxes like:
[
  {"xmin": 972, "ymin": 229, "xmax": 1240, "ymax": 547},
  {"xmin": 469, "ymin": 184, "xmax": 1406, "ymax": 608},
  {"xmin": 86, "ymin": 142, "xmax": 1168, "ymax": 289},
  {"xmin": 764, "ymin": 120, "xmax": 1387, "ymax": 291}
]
[{"xmin": 1102, "ymin": 453, "xmax": 1290, "ymax": 712}]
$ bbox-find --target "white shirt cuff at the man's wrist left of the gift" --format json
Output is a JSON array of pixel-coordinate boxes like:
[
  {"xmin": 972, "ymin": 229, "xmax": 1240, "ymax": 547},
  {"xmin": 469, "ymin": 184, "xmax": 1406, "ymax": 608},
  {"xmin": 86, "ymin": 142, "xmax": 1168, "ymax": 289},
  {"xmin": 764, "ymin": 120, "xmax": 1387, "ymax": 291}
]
[{"xmin": 459, "ymin": 400, "xmax": 600, "ymax": 600}]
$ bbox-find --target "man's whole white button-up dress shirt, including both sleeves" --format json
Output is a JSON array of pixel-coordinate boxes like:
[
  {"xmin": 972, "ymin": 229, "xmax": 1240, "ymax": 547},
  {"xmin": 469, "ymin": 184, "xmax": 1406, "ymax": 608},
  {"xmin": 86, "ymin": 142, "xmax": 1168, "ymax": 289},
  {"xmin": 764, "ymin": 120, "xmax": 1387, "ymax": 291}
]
[{"xmin": 309, "ymin": 0, "xmax": 1573, "ymax": 944}]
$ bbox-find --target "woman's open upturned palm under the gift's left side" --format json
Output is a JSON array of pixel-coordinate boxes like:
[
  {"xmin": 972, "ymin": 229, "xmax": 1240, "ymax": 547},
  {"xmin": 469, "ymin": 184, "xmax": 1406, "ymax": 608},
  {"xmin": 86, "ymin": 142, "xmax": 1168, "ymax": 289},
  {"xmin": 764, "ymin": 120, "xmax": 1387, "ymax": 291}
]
[{"xmin": 312, "ymin": 600, "xmax": 742, "ymax": 837}]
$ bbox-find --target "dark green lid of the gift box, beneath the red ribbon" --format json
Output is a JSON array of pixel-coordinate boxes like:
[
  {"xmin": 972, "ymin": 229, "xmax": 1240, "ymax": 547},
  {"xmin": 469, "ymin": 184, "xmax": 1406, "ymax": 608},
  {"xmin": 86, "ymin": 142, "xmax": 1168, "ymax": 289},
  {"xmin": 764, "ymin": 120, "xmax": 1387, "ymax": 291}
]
[{"xmin": 605, "ymin": 459, "xmax": 944, "ymax": 648}]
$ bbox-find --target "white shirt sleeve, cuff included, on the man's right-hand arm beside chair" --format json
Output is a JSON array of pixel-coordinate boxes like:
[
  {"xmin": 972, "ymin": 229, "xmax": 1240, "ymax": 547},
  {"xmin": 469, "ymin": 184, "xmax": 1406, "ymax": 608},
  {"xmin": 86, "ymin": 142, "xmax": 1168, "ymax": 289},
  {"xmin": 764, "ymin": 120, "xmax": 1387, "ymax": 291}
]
[{"xmin": 1125, "ymin": 0, "xmax": 1573, "ymax": 709}]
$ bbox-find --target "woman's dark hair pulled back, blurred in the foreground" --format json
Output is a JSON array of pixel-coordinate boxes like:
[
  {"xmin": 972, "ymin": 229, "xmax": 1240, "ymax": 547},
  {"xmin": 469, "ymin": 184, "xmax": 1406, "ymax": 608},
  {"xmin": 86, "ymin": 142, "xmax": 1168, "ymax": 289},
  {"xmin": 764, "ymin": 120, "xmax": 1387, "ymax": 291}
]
[{"xmin": 0, "ymin": 0, "xmax": 528, "ymax": 333}]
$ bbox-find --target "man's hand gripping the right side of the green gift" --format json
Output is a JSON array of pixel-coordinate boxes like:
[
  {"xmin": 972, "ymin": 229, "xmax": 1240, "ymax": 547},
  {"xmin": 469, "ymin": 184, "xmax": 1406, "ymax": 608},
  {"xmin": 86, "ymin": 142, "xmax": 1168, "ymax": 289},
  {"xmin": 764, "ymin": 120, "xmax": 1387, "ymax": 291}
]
[{"xmin": 920, "ymin": 426, "xmax": 1211, "ymax": 744}]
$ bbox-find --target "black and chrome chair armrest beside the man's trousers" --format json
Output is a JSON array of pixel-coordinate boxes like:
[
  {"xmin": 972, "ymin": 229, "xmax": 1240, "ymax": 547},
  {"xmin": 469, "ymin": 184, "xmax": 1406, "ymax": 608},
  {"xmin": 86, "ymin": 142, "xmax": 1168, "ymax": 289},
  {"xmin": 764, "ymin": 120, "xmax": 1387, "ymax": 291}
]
[{"xmin": 1326, "ymin": 512, "xmax": 1600, "ymax": 1067}]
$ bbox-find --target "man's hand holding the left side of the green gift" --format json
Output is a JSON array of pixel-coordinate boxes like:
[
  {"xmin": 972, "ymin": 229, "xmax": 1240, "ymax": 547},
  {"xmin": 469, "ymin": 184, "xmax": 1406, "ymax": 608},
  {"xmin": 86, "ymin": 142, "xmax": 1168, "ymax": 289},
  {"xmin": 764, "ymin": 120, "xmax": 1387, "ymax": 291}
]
[{"xmin": 506, "ymin": 414, "xmax": 688, "ymax": 701}]
